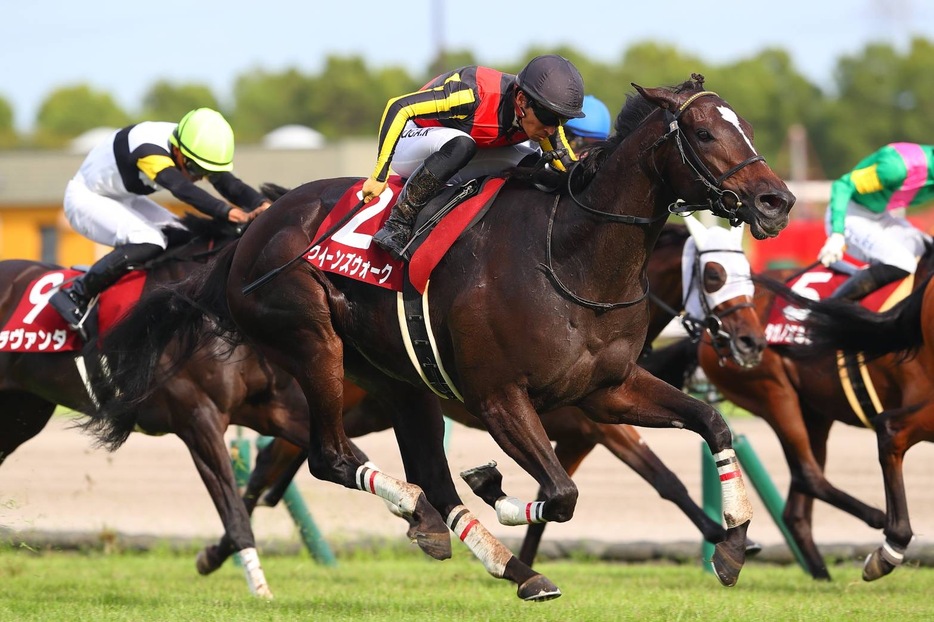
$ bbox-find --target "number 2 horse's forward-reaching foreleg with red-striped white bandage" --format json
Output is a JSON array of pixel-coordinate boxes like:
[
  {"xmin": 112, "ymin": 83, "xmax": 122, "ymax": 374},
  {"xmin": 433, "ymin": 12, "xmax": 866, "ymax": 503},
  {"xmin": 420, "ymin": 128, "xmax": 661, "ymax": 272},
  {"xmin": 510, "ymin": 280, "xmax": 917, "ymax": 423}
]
[{"xmin": 581, "ymin": 368, "xmax": 752, "ymax": 586}]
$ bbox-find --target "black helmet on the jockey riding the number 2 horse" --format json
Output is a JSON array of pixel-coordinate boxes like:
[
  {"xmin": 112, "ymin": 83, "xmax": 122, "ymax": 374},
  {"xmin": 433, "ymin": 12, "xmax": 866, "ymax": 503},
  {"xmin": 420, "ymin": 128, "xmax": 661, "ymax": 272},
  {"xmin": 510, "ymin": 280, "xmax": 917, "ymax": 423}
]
[{"xmin": 516, "ymin": 54, "xmax": 584, "ymax": 119}]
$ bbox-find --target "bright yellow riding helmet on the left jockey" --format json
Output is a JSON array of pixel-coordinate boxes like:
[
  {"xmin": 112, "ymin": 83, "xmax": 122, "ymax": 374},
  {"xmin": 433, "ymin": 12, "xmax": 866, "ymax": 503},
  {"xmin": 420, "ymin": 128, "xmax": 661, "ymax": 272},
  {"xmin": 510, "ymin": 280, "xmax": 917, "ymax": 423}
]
[{"xmin": 169, "ymin": 108, "xmax": 234, "ymax": 173}]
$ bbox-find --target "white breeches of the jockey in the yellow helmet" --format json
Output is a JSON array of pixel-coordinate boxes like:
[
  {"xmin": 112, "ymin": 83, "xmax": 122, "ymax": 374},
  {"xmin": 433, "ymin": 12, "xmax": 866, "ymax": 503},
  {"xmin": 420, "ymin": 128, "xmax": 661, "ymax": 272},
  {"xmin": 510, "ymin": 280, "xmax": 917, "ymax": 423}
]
[{"xmin": 64, "ymin": 175, "xmax": 178, "ymax": 248}]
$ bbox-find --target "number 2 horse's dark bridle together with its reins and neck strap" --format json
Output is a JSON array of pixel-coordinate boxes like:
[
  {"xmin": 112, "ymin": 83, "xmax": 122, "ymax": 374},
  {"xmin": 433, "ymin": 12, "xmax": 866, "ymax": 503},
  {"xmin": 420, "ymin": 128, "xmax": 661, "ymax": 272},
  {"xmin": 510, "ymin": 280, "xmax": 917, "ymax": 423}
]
[{"xmin": 539, "ymin": 91, "xmax": 765, "ymax": 312}]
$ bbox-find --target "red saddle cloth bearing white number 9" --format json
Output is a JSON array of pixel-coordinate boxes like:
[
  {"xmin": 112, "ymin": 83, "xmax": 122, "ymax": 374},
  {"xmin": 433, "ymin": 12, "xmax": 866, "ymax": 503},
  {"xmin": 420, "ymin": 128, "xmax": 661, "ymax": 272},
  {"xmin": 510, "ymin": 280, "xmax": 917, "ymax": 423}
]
[{"xmin": 0, "ymin": 269, "xmax": 146, "ymax": 352}]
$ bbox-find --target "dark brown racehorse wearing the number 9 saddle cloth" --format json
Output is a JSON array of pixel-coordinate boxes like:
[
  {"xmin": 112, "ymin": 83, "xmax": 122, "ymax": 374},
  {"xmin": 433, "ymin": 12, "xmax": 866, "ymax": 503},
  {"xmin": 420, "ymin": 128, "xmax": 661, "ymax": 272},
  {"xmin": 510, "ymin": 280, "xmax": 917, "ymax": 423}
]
[{"xmin": 0, "ymin": 216, "xmax": 334, "ymax": 597}]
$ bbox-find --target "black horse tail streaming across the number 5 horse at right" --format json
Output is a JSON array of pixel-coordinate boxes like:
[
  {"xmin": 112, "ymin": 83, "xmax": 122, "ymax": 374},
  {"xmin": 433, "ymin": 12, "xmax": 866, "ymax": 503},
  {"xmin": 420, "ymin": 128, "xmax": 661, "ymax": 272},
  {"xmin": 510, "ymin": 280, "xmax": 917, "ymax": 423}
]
[{"xmin": 764, "ymin": 277, "xmax": 930, "ymax": 359}]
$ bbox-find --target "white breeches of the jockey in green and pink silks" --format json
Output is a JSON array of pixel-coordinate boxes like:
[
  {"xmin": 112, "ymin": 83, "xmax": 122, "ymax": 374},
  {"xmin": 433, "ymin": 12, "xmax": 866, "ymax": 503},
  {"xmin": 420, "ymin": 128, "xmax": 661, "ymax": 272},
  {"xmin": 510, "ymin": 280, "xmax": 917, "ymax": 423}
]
[{"xmin": 825, "ymin": 201, "xmax": 931, "ymax": 274}]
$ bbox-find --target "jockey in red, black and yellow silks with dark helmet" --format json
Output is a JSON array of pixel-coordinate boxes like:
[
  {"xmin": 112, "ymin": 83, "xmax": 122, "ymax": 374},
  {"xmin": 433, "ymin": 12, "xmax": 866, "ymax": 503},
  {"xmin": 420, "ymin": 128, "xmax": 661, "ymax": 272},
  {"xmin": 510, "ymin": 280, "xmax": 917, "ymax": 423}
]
[{"xmin": 363, "ymin": 54, "xmax": 584, "ymax": 259}]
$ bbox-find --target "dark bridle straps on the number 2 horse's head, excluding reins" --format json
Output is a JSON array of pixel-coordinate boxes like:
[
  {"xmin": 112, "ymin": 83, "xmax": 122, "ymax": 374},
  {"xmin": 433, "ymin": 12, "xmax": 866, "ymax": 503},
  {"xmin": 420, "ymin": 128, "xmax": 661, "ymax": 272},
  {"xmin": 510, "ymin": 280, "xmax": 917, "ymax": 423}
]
[{"xmin": 647, "ymin": 91, "xmax": 765, "ymax": 227}]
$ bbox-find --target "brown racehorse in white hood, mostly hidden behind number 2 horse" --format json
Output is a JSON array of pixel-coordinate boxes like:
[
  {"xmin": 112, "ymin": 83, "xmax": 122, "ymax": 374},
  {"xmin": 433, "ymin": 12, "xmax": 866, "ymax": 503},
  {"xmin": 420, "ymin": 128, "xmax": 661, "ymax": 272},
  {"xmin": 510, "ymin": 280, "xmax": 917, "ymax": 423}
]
[{"xmin": 211, "ymin": 216, "xmax": 765, "ymax": 565}]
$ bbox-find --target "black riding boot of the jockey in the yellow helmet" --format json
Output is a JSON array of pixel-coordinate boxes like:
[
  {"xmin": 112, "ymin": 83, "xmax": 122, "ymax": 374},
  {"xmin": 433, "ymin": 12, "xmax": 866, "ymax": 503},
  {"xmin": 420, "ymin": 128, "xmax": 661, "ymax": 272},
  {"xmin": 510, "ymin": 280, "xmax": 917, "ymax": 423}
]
[{"xmin": 49, "ymin": 244, "xmax": 162, "ymax": 327}]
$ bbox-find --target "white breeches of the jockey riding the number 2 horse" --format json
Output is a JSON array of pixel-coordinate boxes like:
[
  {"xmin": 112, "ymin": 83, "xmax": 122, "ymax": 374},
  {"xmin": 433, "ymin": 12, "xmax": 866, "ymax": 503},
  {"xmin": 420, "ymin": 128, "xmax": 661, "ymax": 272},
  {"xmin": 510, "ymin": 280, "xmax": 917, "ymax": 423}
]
[{"xmin": 392, "ymin": 121, "xmax": 540, "ymax": 184}]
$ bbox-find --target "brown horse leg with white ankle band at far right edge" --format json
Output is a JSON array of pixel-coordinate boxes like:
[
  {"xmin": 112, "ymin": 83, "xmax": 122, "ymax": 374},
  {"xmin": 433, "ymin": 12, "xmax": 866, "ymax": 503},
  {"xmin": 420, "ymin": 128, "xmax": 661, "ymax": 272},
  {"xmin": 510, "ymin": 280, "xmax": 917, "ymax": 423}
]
[{"xmin": 863, "ymin": 409, "xmax": 934, "ymax": 581}]
